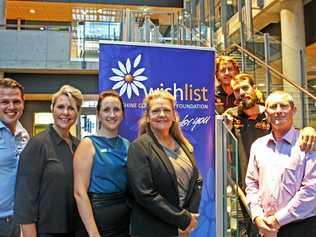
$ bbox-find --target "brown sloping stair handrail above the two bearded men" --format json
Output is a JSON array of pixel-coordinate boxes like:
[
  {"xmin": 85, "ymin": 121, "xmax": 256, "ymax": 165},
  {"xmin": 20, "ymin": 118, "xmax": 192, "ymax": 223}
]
[{"xmin": 224, "ymin": 43, "xmax": 316, "ymax": 100}]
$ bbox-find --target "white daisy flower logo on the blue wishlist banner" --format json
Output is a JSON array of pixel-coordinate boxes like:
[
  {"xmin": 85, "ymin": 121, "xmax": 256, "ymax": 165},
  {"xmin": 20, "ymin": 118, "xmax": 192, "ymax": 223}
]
[{"xmin": 110, "ymin": 54, "xmax": 148, "ymax": 98}]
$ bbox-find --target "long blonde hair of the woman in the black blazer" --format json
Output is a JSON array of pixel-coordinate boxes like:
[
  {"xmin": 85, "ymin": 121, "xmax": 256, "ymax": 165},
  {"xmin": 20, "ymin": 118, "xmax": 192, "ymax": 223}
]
[{"xmin": 138, "ymin": 89, "xmax": 193, "ymax": 151}]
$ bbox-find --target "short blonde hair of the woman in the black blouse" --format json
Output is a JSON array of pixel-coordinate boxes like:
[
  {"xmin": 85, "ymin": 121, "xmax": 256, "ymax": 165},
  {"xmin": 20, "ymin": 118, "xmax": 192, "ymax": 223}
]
[{"xmin": 51, "ymin": 85, "xmax": 83, "ymax": 113}]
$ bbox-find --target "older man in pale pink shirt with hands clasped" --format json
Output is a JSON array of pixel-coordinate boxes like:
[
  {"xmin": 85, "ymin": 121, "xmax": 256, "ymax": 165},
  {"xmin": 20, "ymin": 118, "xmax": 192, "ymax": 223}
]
[{"xmin": 246, "ymin": 91, "xmax": 316, "ymax": 237}]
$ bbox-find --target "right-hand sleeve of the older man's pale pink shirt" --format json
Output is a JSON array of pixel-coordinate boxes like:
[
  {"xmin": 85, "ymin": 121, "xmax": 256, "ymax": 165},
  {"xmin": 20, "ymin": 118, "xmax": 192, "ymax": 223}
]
[{"xmin": 275, "ymin": 152, "xmax": 316, "ymax": 225}]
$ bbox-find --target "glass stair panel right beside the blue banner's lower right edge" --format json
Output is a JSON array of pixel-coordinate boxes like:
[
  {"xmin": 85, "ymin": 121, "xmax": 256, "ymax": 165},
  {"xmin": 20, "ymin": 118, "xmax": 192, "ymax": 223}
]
[{"xmin": 215, "ymin": 116, "xmax": 242, "ymax": 237}]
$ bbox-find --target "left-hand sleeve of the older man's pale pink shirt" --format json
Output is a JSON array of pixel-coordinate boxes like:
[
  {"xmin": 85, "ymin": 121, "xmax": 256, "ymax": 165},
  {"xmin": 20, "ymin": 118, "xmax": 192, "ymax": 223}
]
[{"xmin": 245, "ymin": 144, "xmax": 264, "ymax": 220}]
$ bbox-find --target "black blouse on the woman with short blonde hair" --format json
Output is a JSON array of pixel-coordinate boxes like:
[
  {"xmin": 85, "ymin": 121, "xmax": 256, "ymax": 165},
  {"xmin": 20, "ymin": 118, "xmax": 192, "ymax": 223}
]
[{"xmin": 14, "ymin": 126, "xmax": 79, "ymax": 233}]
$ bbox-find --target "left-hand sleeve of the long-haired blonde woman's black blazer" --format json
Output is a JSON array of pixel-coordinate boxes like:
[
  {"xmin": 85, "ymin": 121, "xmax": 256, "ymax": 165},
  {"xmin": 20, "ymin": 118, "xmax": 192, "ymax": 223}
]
[{"xmin": 127, "ymin": 142, "xmax": 191, "ymax": 230}]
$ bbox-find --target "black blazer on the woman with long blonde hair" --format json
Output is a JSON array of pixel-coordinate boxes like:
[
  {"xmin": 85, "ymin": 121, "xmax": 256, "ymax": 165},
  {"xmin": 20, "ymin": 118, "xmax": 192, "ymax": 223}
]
[{"xmin": 127, "ymin": 132, "xmax": 202, "ymax": 237}]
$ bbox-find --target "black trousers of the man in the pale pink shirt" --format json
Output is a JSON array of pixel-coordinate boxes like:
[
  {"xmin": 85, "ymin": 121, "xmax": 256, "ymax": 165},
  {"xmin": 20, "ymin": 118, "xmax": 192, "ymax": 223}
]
[{"xmin": 278, "ymin": 216, "xmax": 316, "ymax": 237}]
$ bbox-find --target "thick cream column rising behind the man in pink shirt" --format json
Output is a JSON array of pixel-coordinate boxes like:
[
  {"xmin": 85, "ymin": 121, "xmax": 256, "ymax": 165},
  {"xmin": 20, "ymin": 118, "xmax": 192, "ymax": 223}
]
[{"xmin": 280, "ymin": 0, "xmax": 305, "ymax": 127}]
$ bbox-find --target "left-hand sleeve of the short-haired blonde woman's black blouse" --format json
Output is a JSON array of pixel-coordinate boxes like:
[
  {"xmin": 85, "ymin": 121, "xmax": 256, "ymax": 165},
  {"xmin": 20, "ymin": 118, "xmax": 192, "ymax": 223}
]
[{"xmin": 14, "ymin": 138, "xmax": 46, "ymax": 224}]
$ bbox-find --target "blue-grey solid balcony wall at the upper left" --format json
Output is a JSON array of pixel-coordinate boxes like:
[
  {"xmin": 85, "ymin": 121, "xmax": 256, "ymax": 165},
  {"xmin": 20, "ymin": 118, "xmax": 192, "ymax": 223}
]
[{"xmin": 0, "ymin": 25, "xmax": 80, "ymax": 69}]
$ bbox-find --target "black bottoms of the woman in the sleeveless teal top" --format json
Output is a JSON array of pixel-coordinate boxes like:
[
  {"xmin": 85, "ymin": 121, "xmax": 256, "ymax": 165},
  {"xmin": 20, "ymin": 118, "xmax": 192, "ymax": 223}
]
[{"xmin": 76, "ymin": 193, "xmax": 130, "ymax": 237}]
